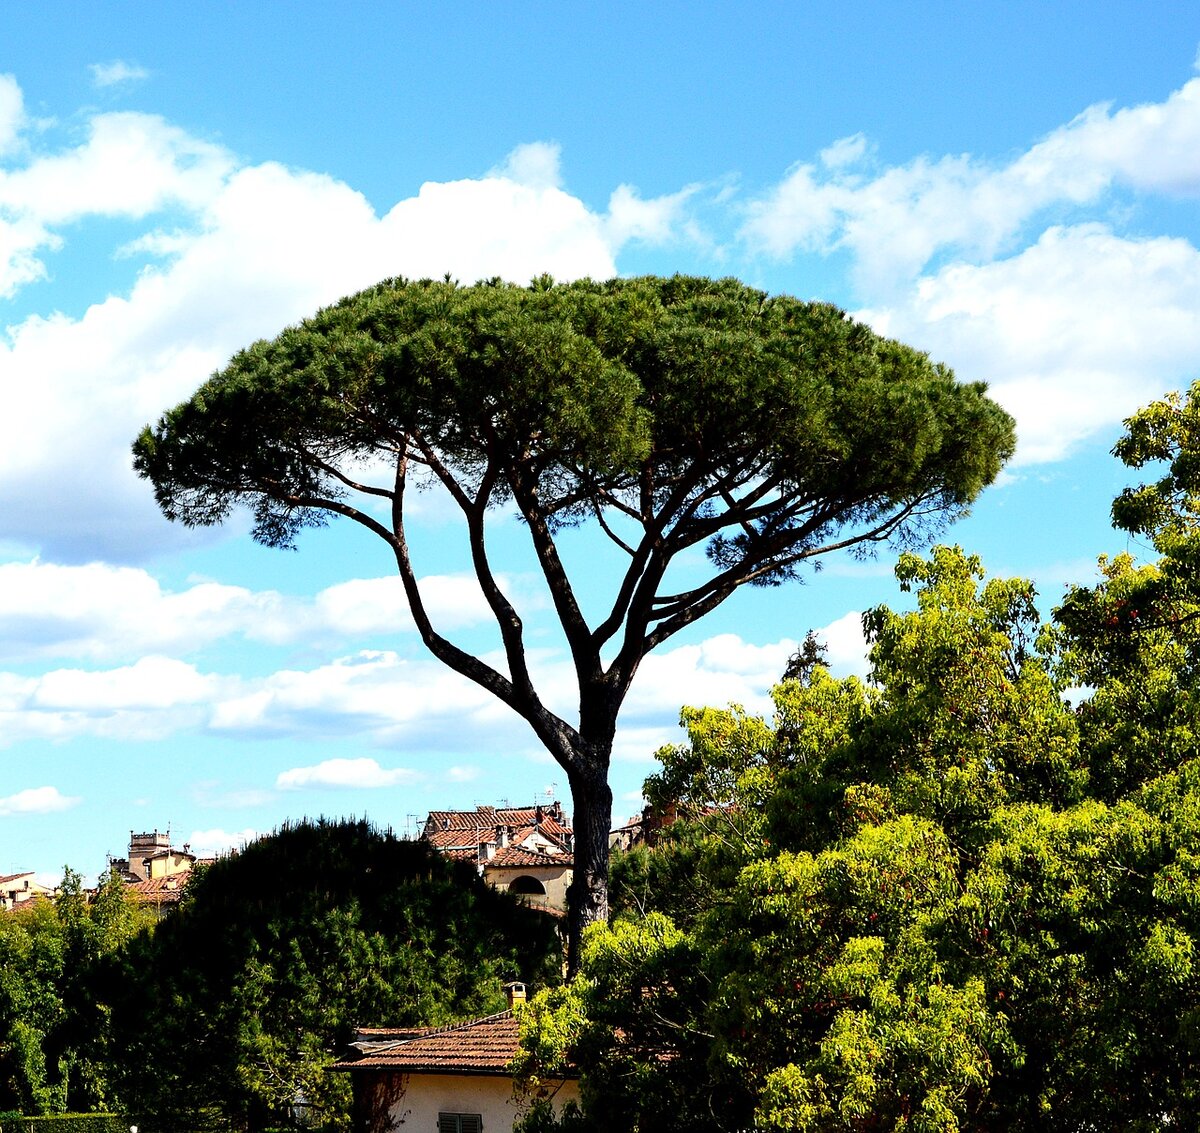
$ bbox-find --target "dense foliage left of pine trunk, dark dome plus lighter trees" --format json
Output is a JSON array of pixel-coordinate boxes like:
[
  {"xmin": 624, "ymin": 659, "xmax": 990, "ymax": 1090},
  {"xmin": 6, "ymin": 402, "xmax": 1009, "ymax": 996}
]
[{"xmin": 0, "ymin": 821, "xmax": 562, "ymax": 1131}]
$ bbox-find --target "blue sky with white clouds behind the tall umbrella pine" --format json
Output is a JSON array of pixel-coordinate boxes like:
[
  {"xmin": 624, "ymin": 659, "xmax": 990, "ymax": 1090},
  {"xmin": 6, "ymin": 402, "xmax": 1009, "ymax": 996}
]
[{"xmin": 0, "ymin": 0, "xmax": 1200, "ymax": 875}]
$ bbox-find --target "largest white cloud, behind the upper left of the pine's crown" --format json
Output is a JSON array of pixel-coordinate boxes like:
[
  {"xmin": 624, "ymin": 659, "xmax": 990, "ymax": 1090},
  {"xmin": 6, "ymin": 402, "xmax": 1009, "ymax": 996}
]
[{"xmin": 0, "ymin": 86, "xmax": 674, "ymax": 562}]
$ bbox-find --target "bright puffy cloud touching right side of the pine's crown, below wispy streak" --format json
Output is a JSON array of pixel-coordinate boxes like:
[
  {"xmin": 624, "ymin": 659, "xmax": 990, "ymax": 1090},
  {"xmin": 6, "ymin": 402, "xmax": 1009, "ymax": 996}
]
[{"xmin": 860, "ymin": 224, "xmax": 1200, "ymax": 464}]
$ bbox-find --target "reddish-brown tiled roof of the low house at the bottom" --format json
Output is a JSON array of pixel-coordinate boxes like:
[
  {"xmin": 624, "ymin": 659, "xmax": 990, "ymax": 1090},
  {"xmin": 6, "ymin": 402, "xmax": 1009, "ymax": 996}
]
[{"xmin": 336, "ymin": 1011, "xmax": 528, "ymax": 1074}]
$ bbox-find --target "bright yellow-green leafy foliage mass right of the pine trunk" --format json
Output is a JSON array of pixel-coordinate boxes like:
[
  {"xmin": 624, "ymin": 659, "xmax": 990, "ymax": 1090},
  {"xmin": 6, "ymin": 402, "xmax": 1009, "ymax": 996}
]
[{"xmin": 522, "ymin": 379, "xmax": 1200, "ymax": 1133}]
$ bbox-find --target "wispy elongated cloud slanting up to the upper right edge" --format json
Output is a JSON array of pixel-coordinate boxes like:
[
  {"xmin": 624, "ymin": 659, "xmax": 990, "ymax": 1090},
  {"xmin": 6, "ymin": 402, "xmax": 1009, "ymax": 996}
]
[{"xmin": 743, "ymin": 79, "xmax": 1200, "ymax": 295}]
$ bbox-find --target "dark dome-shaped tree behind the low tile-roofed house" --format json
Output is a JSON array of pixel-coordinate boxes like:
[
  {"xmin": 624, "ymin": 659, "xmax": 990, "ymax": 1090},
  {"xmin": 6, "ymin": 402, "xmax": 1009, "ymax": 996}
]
[{"xmin": 114, "ymin": 821, "xmax": 562, "ymax": 1129}]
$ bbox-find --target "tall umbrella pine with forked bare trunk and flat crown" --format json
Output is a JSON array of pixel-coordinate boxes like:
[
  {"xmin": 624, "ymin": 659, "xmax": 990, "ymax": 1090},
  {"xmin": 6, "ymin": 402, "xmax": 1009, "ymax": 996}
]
[{"xmin": 134, "ymin": 276, "xmax": 1013, "ymax": 964}]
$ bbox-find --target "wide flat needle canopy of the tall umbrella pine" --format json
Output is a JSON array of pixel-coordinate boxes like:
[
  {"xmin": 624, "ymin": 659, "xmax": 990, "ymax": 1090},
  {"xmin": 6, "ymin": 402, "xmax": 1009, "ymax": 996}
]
[{"xmin": 134, "ymin": 276, "xmax": 1013, "ymax": 560}]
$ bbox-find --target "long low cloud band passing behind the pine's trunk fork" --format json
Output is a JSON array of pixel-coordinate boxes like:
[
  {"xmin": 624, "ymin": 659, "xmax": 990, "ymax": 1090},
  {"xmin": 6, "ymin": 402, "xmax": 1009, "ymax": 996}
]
[{"xmin": 0, "ymin": 634, "xmax": 820, "ymax": 758}]
